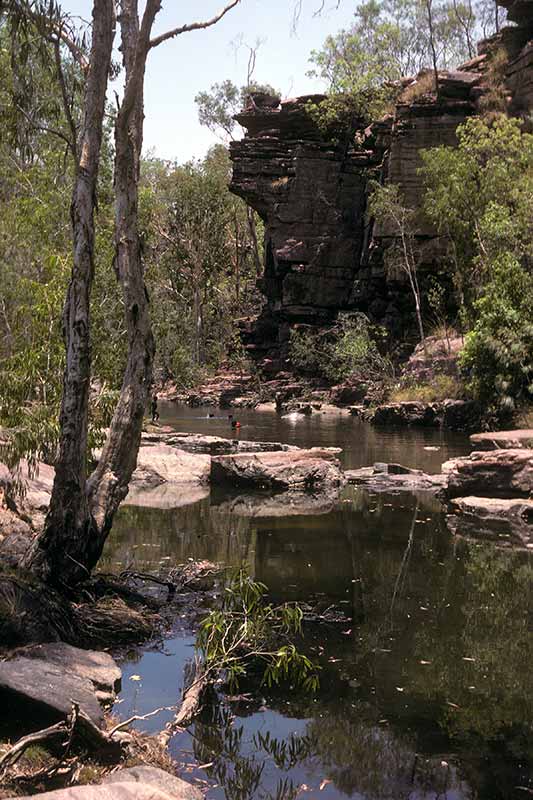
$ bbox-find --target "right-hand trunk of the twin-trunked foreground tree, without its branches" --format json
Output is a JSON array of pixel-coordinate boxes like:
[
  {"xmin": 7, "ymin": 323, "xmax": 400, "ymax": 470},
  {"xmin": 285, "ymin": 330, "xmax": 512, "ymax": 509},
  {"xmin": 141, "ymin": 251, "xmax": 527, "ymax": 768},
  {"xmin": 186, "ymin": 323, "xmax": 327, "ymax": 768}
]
[{"xmin": 87, "ymin": 0, "xmax": 156, "ymax": 544}]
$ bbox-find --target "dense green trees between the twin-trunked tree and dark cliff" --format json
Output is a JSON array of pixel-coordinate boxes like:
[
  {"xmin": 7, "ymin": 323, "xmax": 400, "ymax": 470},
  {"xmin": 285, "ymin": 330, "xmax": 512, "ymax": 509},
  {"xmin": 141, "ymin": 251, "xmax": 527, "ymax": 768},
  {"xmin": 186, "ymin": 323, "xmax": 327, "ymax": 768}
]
[{"xmin": 141, "ymin": 145, "xmax": 258, "ymax": 385}]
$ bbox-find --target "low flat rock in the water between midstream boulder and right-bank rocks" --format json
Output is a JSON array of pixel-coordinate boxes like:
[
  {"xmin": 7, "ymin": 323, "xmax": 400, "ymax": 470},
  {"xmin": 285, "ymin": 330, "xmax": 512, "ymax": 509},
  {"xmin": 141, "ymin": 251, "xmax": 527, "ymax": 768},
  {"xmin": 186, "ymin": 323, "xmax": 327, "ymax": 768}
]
[{"xmin": 345, "ymin": 463, "xmax": 447, "ymax": 492}]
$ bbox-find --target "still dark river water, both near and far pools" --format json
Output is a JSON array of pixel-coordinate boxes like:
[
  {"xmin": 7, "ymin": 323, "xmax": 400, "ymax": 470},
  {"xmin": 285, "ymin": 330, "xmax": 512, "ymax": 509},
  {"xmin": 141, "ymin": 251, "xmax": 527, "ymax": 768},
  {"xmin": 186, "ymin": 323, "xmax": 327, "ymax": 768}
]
[{"xmin": 106, "ymin": 406, "xmax": 533, "ymax": 800}]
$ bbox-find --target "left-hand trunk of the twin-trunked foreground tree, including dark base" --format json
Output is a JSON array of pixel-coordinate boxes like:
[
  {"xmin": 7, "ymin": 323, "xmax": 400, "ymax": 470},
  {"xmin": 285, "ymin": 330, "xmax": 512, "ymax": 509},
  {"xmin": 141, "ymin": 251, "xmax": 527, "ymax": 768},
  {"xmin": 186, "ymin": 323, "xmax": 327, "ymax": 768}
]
[{"xmin": 25, "ymin": 0, "xmax": 115, "ymax": 582}]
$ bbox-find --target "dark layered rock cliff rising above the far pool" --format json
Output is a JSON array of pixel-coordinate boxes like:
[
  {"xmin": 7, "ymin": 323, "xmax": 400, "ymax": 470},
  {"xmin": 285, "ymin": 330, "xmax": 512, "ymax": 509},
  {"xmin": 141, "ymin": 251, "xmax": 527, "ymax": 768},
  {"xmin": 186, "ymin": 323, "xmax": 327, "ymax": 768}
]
[{"xmin": 230, "ymin": 0, "xmax": 533, "ymax": 372}]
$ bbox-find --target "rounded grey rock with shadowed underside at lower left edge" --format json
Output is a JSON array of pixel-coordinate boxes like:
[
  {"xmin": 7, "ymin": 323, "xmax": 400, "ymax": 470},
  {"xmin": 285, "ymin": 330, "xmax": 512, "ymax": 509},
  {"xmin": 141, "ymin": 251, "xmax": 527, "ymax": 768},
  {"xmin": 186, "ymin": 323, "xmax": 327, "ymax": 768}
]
[{"xmin": 0, "ymin": 656, "xmax": 104, "ymax": 728}]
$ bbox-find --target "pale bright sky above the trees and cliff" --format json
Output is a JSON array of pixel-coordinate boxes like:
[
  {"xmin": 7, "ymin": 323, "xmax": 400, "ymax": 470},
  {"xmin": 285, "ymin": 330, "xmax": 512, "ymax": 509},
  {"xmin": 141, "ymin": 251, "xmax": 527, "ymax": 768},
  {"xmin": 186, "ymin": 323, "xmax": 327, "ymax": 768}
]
[{"xmin": 62, "ymin": 0, "xmax": 355, "ymax": 163}]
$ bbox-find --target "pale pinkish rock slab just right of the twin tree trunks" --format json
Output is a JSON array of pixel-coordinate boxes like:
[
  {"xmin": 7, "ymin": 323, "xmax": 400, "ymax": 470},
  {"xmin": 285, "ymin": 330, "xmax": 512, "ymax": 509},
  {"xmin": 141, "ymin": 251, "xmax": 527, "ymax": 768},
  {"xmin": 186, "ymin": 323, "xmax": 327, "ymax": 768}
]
[{"xmin": 131, "ymin": 444, "xmax": 211, "ymax": 487}]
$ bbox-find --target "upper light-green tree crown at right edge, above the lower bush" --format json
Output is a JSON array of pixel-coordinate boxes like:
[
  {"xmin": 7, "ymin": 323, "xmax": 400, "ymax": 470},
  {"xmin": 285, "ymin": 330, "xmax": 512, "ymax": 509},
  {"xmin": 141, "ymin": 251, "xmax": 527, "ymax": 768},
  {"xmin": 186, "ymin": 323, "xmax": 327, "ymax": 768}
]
[{"xmin": 422, "ymin": 114, "xmax": 533, "ymax": 323}]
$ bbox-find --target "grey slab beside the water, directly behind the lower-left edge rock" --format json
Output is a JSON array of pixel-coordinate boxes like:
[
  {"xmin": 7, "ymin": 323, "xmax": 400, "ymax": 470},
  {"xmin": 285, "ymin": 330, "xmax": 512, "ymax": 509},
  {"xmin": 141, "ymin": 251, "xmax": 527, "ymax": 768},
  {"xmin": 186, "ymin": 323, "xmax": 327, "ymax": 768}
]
[{"xmin": 8, "ymin": 642, "xmax": 122, "ymax": 694}]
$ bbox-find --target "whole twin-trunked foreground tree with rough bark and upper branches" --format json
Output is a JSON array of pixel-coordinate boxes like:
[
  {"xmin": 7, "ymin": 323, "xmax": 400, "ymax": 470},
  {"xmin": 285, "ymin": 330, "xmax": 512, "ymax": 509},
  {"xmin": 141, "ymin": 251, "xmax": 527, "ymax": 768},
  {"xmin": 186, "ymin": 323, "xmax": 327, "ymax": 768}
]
[{"xmin": 0, "ymin": 0, "xmax": 240, "ymax": 585}]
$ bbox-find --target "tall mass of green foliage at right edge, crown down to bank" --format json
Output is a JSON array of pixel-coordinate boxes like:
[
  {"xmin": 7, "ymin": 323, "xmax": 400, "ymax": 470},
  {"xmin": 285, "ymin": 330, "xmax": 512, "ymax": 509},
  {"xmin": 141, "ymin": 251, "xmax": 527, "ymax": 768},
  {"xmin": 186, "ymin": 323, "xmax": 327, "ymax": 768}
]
[{"xmin": 423, "ymin": 114, "xmax": 533, "ymax": 414}]
